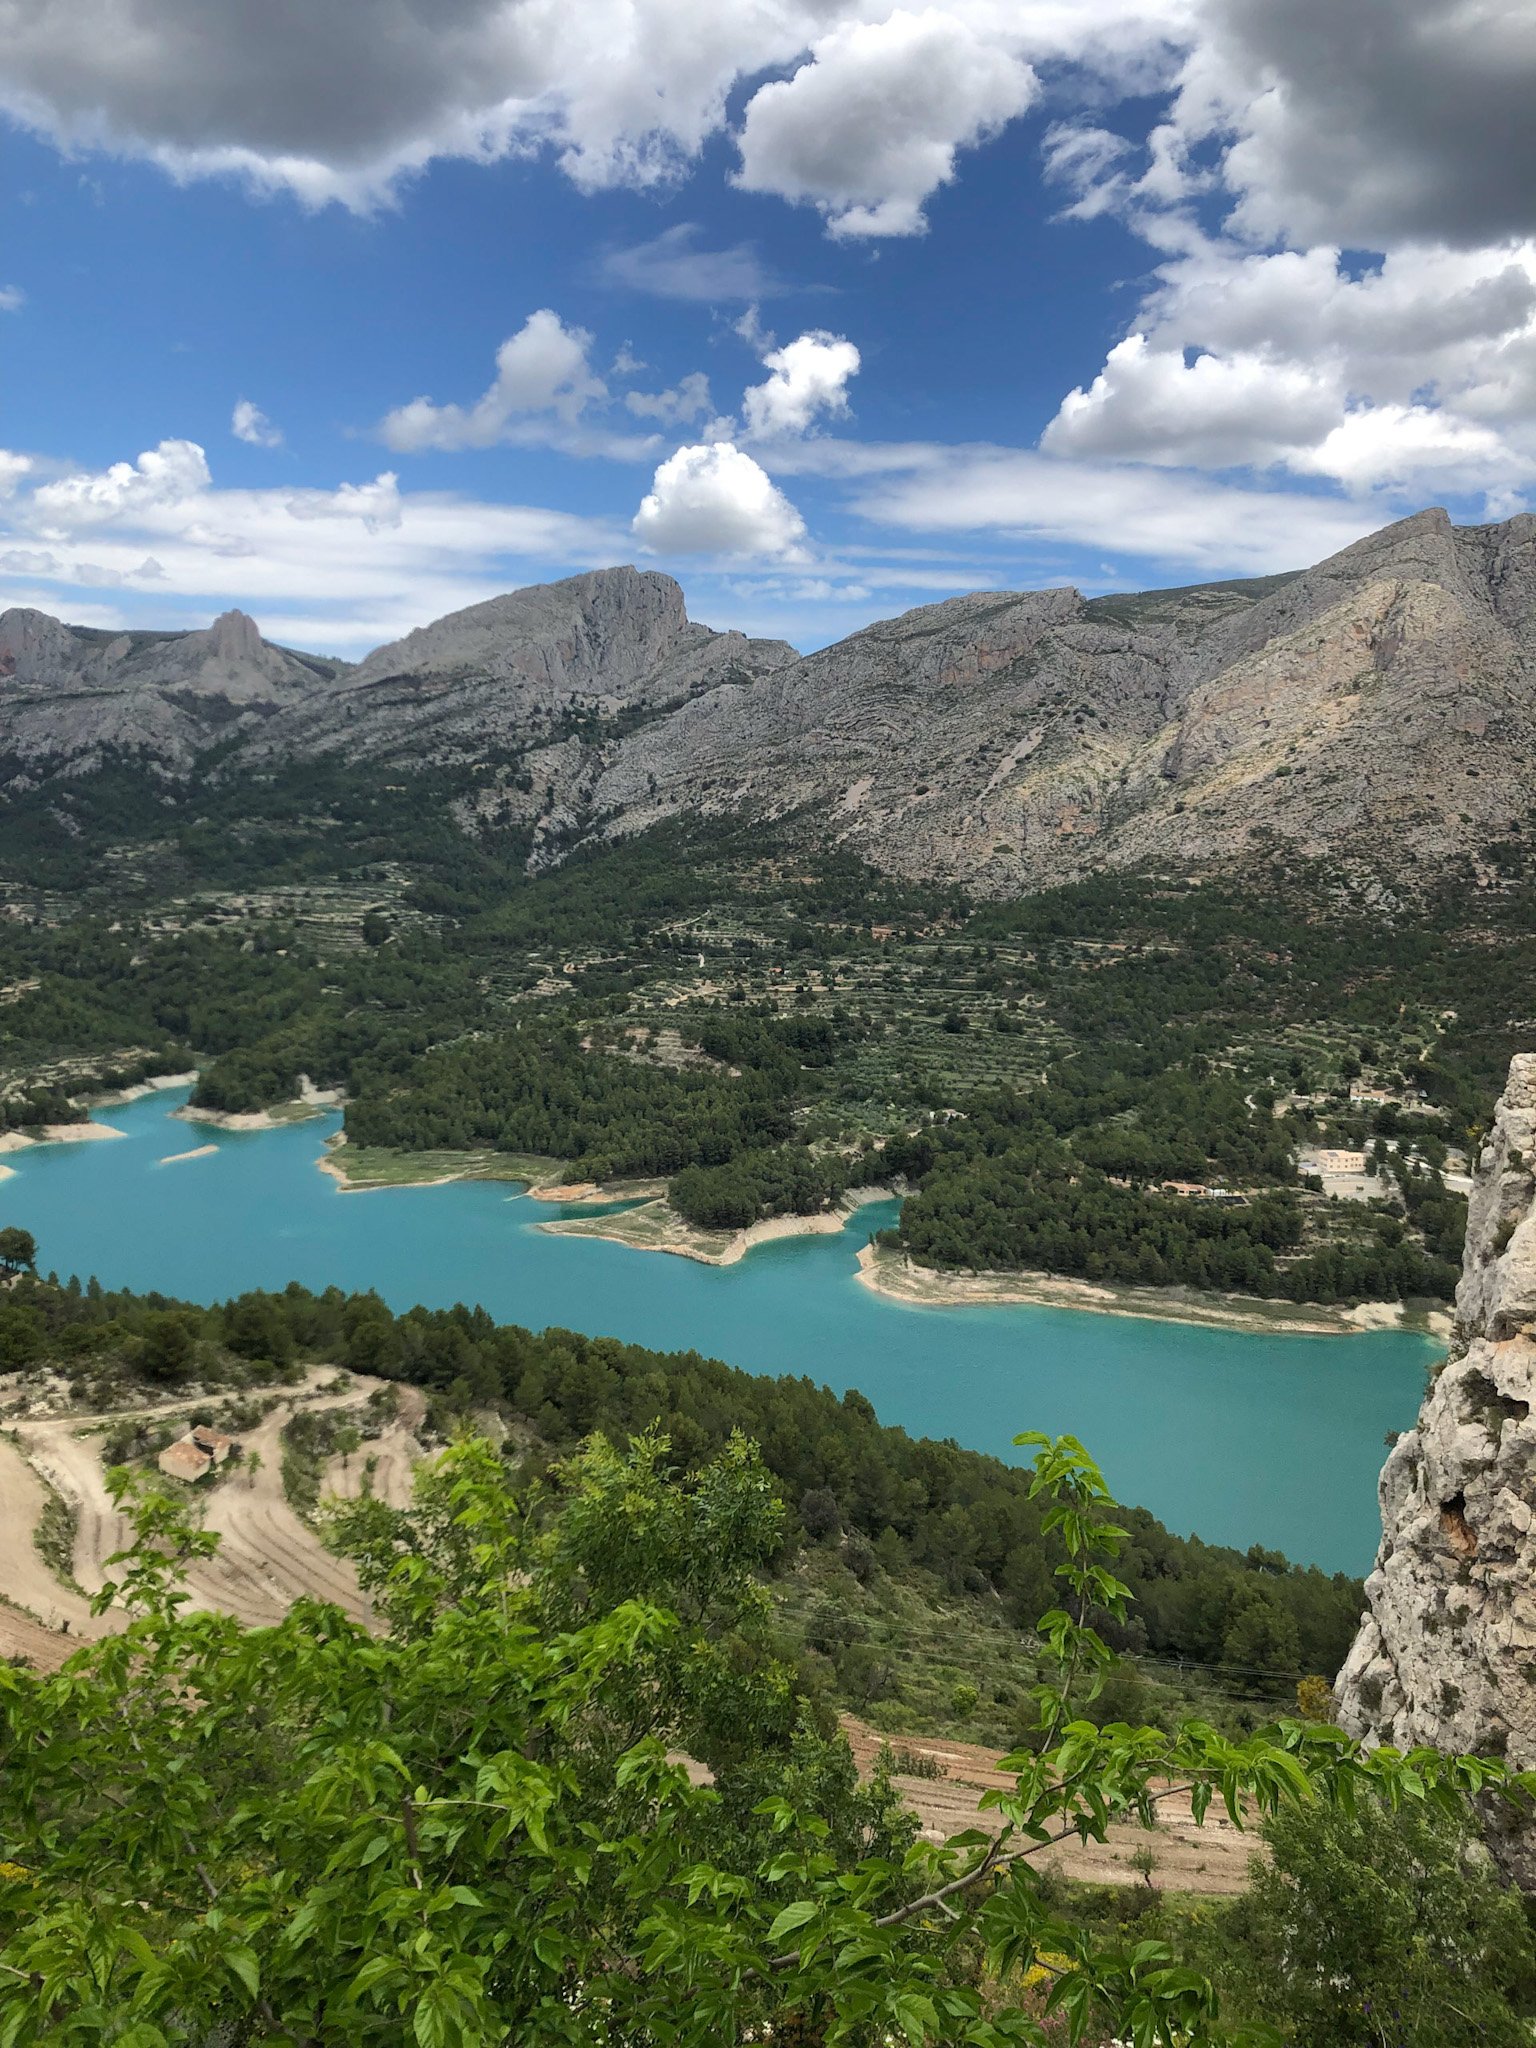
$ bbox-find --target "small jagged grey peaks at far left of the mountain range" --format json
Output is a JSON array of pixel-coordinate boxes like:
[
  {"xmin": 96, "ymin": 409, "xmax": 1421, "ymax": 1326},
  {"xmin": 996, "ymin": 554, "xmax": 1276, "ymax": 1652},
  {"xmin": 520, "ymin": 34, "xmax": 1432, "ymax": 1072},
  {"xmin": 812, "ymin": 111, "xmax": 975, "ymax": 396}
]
[{"xmin": 0, "ymin": 610, "xmax": 336, "ymax": 772}]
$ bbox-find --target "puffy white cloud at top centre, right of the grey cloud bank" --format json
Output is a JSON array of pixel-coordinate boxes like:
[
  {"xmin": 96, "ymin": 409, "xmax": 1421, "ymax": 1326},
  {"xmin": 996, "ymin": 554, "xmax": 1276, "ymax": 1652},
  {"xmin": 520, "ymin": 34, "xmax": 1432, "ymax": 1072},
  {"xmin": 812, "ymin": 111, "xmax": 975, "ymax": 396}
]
[{"xmin": 737, "ymin": 6, "xmax": 1038, "ymax": 236}]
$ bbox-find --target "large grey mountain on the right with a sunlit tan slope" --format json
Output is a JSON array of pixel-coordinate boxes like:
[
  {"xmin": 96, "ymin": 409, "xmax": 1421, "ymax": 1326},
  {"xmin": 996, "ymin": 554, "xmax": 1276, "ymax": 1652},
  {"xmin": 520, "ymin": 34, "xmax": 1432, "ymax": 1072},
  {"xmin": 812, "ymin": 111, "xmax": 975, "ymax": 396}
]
[{"xmin": 561, "ymin": 512, "xmax": 1536, "ymax": 893}]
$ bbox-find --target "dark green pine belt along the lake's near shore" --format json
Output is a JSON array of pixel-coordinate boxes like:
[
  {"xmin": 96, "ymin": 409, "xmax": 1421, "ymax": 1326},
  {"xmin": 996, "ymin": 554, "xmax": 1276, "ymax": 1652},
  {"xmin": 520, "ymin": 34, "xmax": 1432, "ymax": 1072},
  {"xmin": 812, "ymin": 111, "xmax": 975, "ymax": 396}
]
[{"xmin": 0, "ymin": 1276, "xmax": 1362, "ymax": 1690}]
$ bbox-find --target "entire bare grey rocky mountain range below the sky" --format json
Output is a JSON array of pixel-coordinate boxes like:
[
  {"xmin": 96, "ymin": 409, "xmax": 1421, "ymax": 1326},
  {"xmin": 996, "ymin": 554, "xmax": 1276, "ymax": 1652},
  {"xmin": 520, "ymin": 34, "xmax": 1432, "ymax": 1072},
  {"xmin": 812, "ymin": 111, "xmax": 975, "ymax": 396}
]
[{"xmin": 0, "ymin": 510, "xmax": 1536, "ymax": 893}]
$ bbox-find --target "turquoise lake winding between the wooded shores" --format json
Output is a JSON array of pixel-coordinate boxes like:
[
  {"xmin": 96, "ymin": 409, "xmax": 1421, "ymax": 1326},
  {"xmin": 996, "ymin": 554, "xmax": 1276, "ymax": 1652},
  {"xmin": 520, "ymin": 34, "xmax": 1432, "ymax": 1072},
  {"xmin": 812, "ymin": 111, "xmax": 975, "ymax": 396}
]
[{"xmin": 0, "ymin": 1090, "xmax": 1440, "ymax": 1571}]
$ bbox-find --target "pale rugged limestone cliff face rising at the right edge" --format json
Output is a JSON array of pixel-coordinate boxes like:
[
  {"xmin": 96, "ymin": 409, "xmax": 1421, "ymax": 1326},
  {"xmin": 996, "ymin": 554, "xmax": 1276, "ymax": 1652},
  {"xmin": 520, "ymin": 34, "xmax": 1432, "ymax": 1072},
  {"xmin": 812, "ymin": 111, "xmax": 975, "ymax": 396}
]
[{"xmin": 1339, "ymin": 1053, "xmax": 1536, "ymax": 1888}]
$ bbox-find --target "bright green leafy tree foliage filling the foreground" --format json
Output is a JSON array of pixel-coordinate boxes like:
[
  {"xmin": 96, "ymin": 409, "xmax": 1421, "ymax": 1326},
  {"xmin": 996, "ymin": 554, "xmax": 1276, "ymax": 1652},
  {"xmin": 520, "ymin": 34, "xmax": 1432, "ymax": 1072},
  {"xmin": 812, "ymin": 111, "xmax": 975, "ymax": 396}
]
[{"xmin": 0, "ymin": 1436, "xmax": 1526, "ymax": 2048}]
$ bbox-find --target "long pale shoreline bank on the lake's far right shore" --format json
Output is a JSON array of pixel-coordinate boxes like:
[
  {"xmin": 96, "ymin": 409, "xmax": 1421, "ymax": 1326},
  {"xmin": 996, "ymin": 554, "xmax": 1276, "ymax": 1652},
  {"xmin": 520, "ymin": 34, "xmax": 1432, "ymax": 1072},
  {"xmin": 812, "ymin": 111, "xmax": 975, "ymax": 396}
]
[{"xmin": 858, "ymin": 1245, "xmax": 1450, "ymax": 1337}]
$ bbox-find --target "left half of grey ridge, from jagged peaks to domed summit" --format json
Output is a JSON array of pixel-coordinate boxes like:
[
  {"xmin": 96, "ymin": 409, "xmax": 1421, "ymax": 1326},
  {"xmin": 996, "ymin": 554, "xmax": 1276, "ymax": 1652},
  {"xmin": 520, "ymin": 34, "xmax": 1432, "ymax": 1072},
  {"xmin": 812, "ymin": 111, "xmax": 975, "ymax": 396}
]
[{"xmin": 0, "ymin": 567, "xmax": 797, "ymax": 786}]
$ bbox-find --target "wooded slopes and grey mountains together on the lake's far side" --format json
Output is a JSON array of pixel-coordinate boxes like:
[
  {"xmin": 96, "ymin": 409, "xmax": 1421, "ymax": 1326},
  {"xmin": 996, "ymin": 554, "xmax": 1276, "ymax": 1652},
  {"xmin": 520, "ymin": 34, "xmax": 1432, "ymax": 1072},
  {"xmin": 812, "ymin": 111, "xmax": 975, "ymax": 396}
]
[{"xmin": 0, "ymin": 512, "xmax": 1536, "ymax": 1323}]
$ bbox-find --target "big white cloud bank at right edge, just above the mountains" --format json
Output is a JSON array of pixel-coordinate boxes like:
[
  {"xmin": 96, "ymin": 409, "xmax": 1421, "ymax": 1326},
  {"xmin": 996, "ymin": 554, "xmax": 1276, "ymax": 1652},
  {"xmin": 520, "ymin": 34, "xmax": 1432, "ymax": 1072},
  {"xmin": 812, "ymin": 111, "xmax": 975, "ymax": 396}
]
[{"xmin": 1042, "ymin": 233, "xmax": 1536, "ymax": 496}]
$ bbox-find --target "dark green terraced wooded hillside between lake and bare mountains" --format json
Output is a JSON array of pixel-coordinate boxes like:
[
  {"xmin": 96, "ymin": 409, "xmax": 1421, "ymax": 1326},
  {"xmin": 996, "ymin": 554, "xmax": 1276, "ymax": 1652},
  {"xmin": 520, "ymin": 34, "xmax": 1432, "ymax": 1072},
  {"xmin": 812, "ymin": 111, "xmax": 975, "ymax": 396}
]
[{"xmin": 0, "ymin": 764, "xmax": 1536, "ymax": 1300}]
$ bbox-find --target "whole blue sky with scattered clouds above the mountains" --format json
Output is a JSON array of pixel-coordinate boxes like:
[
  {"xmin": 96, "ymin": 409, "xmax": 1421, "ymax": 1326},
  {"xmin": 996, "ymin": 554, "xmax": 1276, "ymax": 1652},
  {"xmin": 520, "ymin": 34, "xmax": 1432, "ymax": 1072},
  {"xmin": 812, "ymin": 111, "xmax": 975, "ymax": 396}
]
[{"xmin": 0, "ymin": 0, "xmax": 1536, "ymax": 653}]
